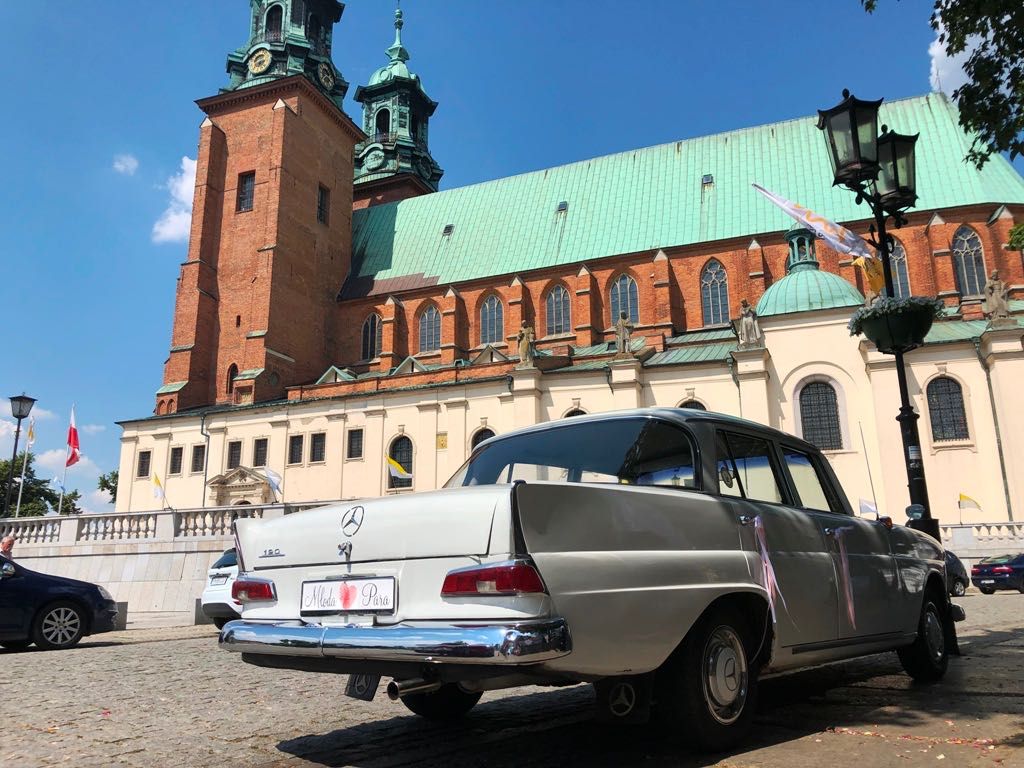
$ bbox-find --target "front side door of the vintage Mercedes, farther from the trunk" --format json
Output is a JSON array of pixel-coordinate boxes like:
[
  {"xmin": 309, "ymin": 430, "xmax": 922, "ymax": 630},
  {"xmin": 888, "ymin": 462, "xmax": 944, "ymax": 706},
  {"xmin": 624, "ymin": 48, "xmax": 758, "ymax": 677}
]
[{"xmin": 780, "ymin": 444, "xmax": 902, "ymax": 639}]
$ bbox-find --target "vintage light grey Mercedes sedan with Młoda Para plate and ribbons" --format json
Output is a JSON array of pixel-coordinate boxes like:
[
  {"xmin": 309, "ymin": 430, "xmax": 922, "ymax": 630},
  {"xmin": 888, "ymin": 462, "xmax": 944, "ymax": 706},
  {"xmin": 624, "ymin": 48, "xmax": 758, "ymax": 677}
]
[{"xmin": 220, "ymin": 409, "xmax": 963, "ymax": 750}]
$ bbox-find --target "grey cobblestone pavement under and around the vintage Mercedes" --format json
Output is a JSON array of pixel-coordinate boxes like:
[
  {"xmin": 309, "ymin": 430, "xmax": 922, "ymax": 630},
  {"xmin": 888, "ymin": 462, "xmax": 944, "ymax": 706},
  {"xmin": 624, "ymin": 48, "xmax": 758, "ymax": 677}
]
[{"xmin": 0, "ymin": 593, "xmax": 1024, "ymax": 768}]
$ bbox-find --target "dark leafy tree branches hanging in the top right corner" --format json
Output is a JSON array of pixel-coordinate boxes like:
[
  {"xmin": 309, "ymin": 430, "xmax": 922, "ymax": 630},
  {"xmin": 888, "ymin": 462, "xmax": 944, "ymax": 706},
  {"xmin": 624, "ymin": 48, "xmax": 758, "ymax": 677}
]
[{"xmin": 860, "ymin": 0, "xmax": 1024, "ymax": 168}]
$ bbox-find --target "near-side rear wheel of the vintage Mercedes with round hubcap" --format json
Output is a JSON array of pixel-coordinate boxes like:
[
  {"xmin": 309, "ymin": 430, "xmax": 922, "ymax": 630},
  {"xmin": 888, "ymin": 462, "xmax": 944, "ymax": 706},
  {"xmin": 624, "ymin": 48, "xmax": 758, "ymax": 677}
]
[{"xmin": 654, "ymin": 606, "xmax": 759, "ymax": 752}]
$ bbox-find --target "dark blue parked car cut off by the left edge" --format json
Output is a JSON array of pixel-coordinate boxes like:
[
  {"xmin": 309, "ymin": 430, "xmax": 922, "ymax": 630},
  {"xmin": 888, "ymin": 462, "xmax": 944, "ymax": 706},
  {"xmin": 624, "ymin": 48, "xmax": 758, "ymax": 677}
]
[{"xmin": 0, "ymin": 557, "xmax": 118, "ymax": 650}]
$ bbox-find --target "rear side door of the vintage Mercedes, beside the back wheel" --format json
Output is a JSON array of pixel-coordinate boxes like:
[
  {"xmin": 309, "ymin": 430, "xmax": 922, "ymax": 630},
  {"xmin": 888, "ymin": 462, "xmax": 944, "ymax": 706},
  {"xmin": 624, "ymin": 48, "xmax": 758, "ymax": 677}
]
[{"xmin": 716, "ymin": 430, "xmax": 839, "ymax": 648}]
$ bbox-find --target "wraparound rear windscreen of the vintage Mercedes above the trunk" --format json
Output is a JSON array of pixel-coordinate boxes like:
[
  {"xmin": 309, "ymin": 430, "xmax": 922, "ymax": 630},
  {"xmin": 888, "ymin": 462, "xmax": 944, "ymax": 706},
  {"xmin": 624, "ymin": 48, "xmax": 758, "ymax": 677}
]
[{"xmin": 445, "ymin": 418, "xmax": 698, "ymax": 488}]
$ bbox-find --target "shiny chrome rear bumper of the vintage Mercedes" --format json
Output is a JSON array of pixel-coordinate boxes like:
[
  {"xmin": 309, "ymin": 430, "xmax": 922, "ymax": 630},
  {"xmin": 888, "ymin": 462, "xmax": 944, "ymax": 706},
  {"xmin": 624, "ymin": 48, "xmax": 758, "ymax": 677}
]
[{"xmin": 219, "ymin": 618, "xmax": 572, "ymax": 665}]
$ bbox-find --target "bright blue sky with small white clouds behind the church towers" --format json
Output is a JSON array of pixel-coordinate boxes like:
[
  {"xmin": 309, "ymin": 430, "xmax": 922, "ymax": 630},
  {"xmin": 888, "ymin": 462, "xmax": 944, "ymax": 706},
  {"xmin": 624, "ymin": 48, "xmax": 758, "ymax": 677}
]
[{"xmin": 0, "ymin": 0, "xmax": 1011, "ymax": 511}]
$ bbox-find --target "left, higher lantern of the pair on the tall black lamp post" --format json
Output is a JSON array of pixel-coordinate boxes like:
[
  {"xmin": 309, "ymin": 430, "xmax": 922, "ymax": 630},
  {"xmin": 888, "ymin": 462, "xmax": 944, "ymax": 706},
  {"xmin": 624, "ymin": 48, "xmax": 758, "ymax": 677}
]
[{"xmin": 818, "ymin": 90, "xmax": 882, "ymax": 188}]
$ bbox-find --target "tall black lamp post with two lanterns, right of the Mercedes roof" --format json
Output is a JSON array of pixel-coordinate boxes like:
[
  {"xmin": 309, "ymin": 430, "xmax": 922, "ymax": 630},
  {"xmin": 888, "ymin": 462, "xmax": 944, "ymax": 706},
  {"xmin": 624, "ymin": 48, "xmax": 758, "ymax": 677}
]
[{"xmin": 818, "ymin": 90, "xmax": 941, "ymax": 541}]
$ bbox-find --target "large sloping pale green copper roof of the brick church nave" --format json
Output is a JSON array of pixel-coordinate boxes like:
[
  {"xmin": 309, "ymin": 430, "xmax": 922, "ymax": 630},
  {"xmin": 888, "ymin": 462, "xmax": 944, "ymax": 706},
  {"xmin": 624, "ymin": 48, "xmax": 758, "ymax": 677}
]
[{"xmin": 343, "ymin": 94, "xmax": 1024, "ymax": 297}]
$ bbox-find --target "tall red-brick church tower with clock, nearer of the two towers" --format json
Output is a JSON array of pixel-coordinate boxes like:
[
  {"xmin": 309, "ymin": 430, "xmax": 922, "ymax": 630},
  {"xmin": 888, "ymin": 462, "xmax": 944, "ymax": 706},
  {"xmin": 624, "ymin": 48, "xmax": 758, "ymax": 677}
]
[{"xmin": 156, "ymin": 0, "xmax": 366, "ymax": 415}]
